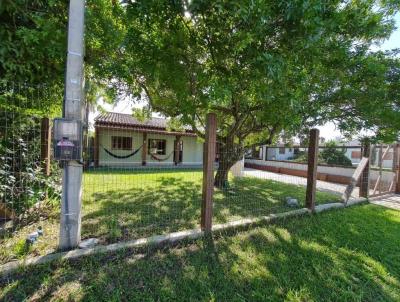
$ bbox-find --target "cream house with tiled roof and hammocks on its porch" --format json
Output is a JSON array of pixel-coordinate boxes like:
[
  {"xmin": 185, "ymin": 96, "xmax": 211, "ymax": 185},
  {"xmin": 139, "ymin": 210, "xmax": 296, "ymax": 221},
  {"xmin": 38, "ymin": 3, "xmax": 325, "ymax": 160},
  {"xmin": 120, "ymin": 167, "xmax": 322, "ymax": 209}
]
[{"xmin": 94, "ymin": 112, "xmax": 203, "ymax": 167}]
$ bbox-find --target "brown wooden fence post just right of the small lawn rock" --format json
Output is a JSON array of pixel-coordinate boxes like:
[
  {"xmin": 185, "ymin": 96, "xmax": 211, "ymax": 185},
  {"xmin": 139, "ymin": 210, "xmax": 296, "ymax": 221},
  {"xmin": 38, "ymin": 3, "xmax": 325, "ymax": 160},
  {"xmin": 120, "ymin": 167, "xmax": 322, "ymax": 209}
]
[{"xmin": 306, "ymin": 129, "xmax": 319, "ymax": 211}]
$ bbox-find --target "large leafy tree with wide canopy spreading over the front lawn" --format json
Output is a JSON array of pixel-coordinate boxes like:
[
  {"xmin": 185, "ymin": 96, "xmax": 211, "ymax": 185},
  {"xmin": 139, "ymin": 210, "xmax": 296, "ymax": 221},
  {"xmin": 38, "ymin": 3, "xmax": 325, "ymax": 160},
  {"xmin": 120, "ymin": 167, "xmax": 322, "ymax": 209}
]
[{"xmin": 115, "ymin": 0, "xmax": 400, "ymax": 187}]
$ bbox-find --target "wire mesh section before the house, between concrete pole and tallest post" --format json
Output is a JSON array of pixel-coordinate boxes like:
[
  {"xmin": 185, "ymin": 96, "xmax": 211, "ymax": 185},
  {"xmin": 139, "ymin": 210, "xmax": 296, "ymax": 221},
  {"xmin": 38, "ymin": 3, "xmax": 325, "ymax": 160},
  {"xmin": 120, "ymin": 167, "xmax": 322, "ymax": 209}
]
[{"xmin": 82, "ymin": 113, "xmax": 203, "ymax": 243}]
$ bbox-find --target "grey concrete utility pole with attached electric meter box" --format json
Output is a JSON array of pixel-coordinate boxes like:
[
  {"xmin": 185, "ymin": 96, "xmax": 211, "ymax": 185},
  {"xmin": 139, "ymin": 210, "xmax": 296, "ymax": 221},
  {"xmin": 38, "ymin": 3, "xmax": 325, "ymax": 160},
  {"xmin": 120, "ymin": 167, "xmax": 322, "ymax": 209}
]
[{"xmin": 54, "ymin": 0, "xmax": 85, "ymax": 250}]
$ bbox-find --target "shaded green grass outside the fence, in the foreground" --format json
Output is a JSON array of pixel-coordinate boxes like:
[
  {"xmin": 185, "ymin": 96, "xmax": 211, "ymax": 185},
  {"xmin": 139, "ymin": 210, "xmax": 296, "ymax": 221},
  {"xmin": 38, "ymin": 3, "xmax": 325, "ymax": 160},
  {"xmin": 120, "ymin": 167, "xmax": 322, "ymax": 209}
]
[{"xmin": 0, "ymin": 205, "xmax": 400, "ymax": 302}]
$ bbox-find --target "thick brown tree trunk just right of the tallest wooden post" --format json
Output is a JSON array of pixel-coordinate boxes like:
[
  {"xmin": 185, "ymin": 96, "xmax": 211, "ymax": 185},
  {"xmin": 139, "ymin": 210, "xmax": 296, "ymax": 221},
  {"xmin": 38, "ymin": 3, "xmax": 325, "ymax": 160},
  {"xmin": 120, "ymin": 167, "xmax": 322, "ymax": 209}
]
[{"xmin": 214, "ymin": 143, "xmax": 243, "ymax": 189}]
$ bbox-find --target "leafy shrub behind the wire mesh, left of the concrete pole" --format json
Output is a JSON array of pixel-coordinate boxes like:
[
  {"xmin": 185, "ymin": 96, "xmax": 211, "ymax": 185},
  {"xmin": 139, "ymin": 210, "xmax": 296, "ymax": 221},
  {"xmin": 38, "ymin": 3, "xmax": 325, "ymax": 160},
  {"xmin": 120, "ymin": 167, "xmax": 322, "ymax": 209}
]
[{"xmin": 0, "ymin": 113, "xmax": 61, "ymax": 215}]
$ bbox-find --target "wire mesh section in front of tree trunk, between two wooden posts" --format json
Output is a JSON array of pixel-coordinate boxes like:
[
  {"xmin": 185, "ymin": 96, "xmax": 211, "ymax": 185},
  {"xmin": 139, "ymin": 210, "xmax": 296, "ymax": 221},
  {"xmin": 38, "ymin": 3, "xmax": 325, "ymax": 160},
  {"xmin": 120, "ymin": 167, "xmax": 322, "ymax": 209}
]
[{"xmin": 214, "ymin": 141, "xmax": 322, "ymax": 223}]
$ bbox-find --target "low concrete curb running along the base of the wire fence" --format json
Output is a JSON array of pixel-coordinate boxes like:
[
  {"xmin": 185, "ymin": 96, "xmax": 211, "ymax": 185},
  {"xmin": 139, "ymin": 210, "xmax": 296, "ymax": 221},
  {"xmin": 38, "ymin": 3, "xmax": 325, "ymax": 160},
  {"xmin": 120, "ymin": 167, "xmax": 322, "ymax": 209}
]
[{"xmin": 0, "ymin": 198, "xmax": 367, "ymax": 276}]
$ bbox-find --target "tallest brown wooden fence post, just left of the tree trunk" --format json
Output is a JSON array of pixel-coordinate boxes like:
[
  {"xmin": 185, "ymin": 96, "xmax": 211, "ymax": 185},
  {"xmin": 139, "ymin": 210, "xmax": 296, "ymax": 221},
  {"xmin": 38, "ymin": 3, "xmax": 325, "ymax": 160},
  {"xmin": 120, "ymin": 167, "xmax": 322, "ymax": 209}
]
[{"xmin": 201, "ymin": 113, "xmax": 217, "ymax": 231}]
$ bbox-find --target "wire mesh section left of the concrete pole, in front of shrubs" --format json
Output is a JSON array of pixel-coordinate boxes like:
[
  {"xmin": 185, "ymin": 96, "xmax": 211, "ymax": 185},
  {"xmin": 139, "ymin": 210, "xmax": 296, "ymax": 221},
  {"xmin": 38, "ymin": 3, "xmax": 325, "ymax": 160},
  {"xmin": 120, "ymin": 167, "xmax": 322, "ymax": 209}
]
[{"xmin": 0, "ymin": 83, "xmax": 61, "ymax": 262}]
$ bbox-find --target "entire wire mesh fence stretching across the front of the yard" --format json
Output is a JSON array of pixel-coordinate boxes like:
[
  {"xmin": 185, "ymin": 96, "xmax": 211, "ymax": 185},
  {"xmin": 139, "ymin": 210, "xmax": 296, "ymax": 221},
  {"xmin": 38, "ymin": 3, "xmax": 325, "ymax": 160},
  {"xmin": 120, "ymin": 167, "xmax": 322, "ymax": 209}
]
[{"xmin": 0, "ymin": 85, "xmax": 399, "ymax": 262}]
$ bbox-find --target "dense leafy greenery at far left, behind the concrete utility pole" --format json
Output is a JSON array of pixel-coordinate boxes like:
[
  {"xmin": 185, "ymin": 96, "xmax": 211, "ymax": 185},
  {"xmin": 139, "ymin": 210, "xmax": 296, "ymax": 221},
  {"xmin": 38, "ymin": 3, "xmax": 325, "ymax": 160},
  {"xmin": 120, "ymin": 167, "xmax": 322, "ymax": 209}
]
[{"xmin": 0, "ymin": 0, "xmax": 123, "ymax": 214}]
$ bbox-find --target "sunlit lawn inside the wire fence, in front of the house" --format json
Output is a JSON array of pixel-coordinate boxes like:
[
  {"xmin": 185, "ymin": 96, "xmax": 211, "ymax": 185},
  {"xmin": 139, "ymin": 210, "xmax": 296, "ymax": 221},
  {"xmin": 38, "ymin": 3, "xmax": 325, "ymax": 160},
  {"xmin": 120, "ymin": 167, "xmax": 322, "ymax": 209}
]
[{"xmin": 0, "ymin": 169, "xmax": 339, "ymax": 263}]
